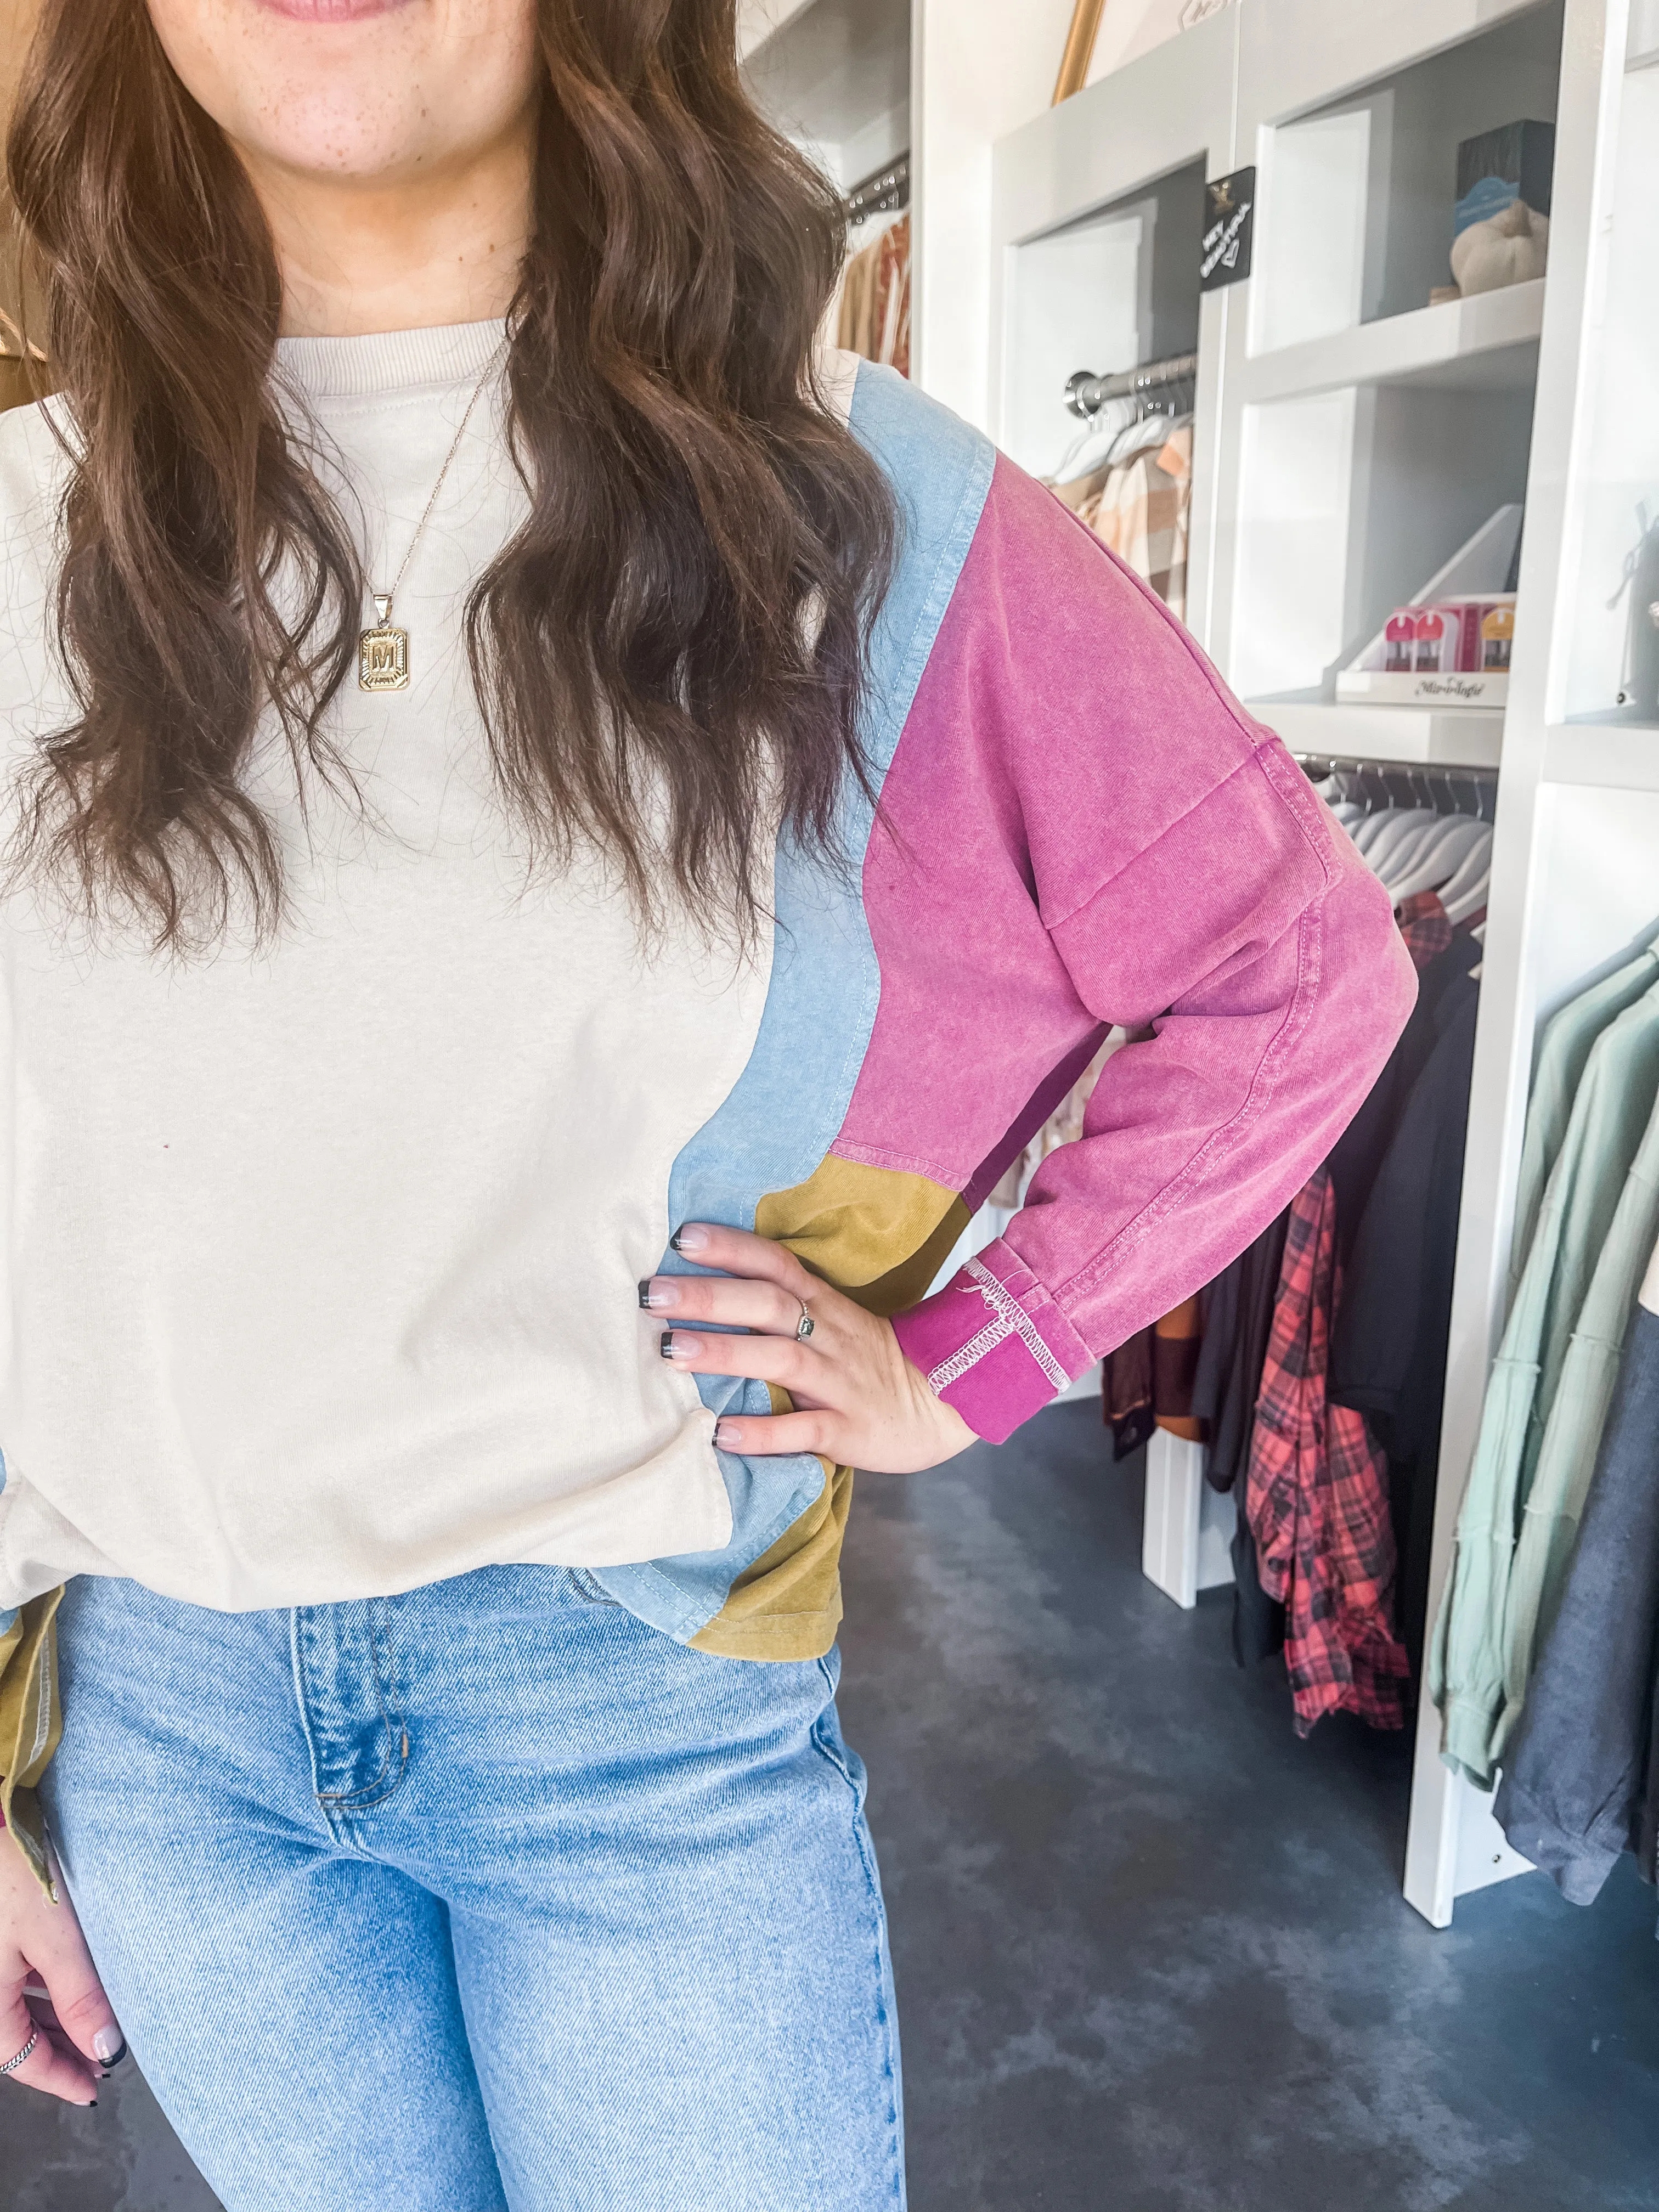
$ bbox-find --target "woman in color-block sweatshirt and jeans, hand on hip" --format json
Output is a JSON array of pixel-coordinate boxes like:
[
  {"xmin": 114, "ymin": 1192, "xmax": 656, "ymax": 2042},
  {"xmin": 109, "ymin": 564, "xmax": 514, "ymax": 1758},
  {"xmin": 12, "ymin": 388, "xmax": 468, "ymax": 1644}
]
[{"xmin": 0, "ymin": 0, "xmax": 1411, "ymax": 2212}]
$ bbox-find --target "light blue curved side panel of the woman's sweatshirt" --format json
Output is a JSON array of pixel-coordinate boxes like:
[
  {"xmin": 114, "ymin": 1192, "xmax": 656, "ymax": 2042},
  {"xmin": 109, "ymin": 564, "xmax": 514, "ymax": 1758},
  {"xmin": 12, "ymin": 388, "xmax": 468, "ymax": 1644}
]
[{"xmin": 597, "ymin": 363, "xmax": 995, "ymax": 1641}]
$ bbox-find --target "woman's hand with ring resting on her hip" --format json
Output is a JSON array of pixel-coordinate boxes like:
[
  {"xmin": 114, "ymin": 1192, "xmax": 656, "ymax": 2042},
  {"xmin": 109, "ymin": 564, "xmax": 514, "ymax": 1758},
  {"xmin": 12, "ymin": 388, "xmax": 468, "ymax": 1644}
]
[{"xmin": 639, "ymin": 1221, "xmax": 975, "ymax": 1475}]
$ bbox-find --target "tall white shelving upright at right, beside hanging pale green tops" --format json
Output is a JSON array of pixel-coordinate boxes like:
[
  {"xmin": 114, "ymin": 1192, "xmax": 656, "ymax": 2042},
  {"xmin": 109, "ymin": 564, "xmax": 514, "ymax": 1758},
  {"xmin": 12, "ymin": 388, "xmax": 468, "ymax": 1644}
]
[{"xmin": 1407, "ymin": 0, "xmax": 1659, "ymax": 1927}]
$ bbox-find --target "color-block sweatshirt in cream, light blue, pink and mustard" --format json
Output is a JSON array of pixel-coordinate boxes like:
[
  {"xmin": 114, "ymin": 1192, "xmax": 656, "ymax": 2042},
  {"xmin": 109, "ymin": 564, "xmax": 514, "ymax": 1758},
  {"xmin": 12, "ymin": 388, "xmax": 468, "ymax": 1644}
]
[{"xmin": 0, "ymin": 325, "xmax": 1413, "ymax": 1657}]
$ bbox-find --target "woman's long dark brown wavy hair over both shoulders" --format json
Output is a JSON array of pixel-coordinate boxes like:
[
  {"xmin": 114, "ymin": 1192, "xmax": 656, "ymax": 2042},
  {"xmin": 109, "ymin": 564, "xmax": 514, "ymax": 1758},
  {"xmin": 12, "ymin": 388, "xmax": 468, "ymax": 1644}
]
[{"xmin": 7, "ymin": 0, "xmax": 898, "ymax": 951}]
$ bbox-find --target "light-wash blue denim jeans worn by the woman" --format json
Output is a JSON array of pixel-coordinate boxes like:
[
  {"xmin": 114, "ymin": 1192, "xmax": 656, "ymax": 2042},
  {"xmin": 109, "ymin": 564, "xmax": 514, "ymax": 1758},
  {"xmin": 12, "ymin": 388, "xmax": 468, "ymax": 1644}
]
[{"xmin": 44, "ymin": 1566, "xmax": 905, "ymax": 2212}]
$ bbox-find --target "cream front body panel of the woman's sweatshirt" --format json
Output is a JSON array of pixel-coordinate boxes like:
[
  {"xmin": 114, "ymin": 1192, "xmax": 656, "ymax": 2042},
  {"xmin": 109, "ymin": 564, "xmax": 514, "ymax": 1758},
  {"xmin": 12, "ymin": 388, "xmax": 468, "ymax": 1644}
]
[{"xmin": 0, "ymin": 323, "xmax": 770, "ymax": 1610}]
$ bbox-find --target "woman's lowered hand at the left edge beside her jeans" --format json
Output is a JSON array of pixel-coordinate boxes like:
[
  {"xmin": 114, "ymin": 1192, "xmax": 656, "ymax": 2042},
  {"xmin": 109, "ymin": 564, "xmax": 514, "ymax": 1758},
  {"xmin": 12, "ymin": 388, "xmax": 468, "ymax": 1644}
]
[{"xmin": 0, "ymin": 1831, "xmax": 126, "ymax": 2103}]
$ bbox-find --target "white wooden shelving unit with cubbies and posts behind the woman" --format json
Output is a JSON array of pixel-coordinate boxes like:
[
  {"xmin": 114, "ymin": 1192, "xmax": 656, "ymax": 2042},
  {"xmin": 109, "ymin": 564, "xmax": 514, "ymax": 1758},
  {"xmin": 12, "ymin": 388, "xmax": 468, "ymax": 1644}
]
[{"xmin": 989, "ymin": 0, "xmax": 1659, "ymax": 1927}]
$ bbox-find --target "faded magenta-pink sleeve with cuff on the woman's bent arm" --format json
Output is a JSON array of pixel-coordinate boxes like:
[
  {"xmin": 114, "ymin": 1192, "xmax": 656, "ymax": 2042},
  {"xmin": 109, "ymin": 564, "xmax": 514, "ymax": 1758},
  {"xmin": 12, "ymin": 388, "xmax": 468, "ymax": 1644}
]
[{"xmin": 896, "ymin": 466, "xmax": 1415, "ymax": 1442}]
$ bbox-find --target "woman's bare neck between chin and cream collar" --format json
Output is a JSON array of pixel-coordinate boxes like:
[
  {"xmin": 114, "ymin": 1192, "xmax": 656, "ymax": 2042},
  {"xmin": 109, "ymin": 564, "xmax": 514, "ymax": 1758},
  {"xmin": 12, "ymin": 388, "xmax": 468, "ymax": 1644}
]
[{"xmin": 236, "ymin": 117, "xmax": 535, "ymax": 338}]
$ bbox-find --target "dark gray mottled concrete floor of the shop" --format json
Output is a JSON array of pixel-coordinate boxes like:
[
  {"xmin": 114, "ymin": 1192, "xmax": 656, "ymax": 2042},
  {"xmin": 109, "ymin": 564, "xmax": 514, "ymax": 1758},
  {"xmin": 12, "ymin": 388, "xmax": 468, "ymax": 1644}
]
[{"xmin": 0, "ymin": 1407, "xmax": 1659, "ymax": 2212}]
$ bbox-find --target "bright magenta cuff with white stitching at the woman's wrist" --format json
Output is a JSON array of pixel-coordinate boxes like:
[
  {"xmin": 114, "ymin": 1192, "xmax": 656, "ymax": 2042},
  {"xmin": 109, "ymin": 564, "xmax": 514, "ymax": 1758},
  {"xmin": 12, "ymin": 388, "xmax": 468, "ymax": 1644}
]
[{"xmin": 894, "ymin": 1239, "xmax": 1093, "ymax": 1444}]
